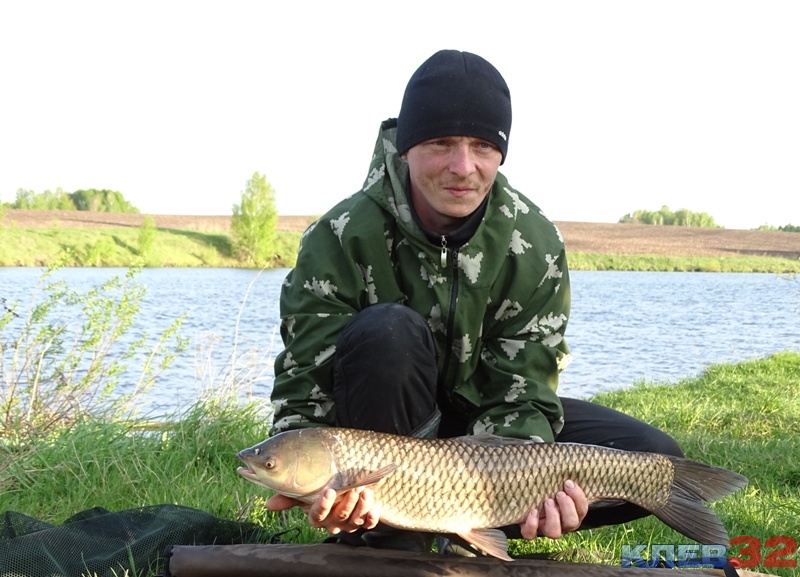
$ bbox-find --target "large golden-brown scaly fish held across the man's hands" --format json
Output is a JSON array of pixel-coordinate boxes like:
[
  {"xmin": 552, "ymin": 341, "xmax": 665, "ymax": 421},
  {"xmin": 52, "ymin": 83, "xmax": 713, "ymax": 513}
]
[{"xmin": 238, "ymin": 427, "xmax": 747, "ymax": 559}]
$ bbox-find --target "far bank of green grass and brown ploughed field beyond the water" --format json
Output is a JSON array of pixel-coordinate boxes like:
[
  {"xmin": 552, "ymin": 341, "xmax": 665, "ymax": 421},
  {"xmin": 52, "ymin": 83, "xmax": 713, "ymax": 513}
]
[{"xmin": 0, "ymin": 210, "xmax": 800, "ymax": 274}]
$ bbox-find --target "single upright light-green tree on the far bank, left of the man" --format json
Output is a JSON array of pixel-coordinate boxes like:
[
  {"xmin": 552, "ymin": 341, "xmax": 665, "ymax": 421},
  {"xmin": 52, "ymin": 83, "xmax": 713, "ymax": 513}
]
[{"xmin": 231, "ymin": 172, "xmax": 278, "ymax": 266}]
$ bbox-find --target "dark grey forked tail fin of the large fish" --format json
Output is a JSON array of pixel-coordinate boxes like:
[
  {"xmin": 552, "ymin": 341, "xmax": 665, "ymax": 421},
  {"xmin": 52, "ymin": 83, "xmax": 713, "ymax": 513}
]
[{"xmin": 651, "ymin": 457, "xmax": 747, "ymax": 545}]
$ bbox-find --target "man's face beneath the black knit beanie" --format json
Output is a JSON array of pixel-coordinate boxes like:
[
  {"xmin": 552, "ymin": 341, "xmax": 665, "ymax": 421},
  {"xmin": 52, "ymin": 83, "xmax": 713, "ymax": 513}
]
[{"xmin": 403, "ymin": 136, "xmax": 503, "ymax": 234}]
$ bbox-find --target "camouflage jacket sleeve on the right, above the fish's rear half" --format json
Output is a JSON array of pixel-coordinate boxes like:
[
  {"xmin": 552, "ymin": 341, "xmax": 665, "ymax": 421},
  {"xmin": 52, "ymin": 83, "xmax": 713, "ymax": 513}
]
[{"xmin": 471, "ymin": 245, "xmax": 571, "ymax": 441}]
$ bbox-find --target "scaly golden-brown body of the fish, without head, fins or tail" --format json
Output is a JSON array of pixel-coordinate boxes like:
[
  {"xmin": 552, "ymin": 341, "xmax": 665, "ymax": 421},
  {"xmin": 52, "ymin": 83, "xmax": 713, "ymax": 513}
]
[{"xmin": 324, "ymin": 429, "xmax": 673, "ymax": 533}]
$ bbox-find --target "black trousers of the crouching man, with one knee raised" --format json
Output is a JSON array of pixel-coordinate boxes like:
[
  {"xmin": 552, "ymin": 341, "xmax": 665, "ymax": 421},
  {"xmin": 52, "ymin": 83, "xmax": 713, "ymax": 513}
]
[{"xmin": 333, "ymin": 304, "xmax": 683, "ymax": 537}]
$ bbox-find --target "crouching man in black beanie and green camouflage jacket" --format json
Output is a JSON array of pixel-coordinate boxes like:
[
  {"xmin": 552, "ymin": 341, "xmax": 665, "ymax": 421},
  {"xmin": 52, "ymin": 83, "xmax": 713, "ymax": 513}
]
[{"xmin": 268, "ymin": 50, "xmax": 681, "ymax": 547}]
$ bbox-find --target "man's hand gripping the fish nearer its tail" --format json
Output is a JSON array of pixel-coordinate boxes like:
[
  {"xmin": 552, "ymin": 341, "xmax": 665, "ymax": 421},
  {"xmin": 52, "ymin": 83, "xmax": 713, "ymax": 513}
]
[{"xmin": 520, "ymin": 481, "xmax": 589, "ymax": 539}]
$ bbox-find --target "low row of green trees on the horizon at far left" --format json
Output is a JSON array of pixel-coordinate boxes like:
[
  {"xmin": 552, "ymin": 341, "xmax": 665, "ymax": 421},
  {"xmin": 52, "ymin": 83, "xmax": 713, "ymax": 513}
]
[{"xmin": 5, "ymin": 188, "xmax": 139, "ymax": 214}]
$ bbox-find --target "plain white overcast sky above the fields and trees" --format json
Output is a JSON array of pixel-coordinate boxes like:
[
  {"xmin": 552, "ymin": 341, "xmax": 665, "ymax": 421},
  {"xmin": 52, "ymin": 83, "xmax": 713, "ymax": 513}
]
[{"xmin": 0, "ymin": 0, "xmax": 800, "ymax": 229}]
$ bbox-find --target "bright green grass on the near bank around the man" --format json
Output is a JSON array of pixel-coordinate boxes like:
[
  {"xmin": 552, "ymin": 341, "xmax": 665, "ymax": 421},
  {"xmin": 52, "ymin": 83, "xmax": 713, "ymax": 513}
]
[{"xmin": 0, "ymin": 353, "xmax": 800, "ymax": 576}]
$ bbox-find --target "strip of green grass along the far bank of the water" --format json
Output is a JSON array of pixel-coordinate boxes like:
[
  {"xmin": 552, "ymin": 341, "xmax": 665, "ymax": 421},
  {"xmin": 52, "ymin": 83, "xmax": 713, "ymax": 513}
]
[{"xmin": 0, "ymin": 227, "xmax": 800, "ymax": 273}]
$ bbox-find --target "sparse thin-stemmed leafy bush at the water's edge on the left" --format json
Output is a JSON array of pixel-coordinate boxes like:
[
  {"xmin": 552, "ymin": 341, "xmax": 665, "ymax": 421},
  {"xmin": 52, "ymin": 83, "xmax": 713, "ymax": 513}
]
[{"xmin": 0, "ymin": 269, "xmax": 187, "ymax": 442}]
